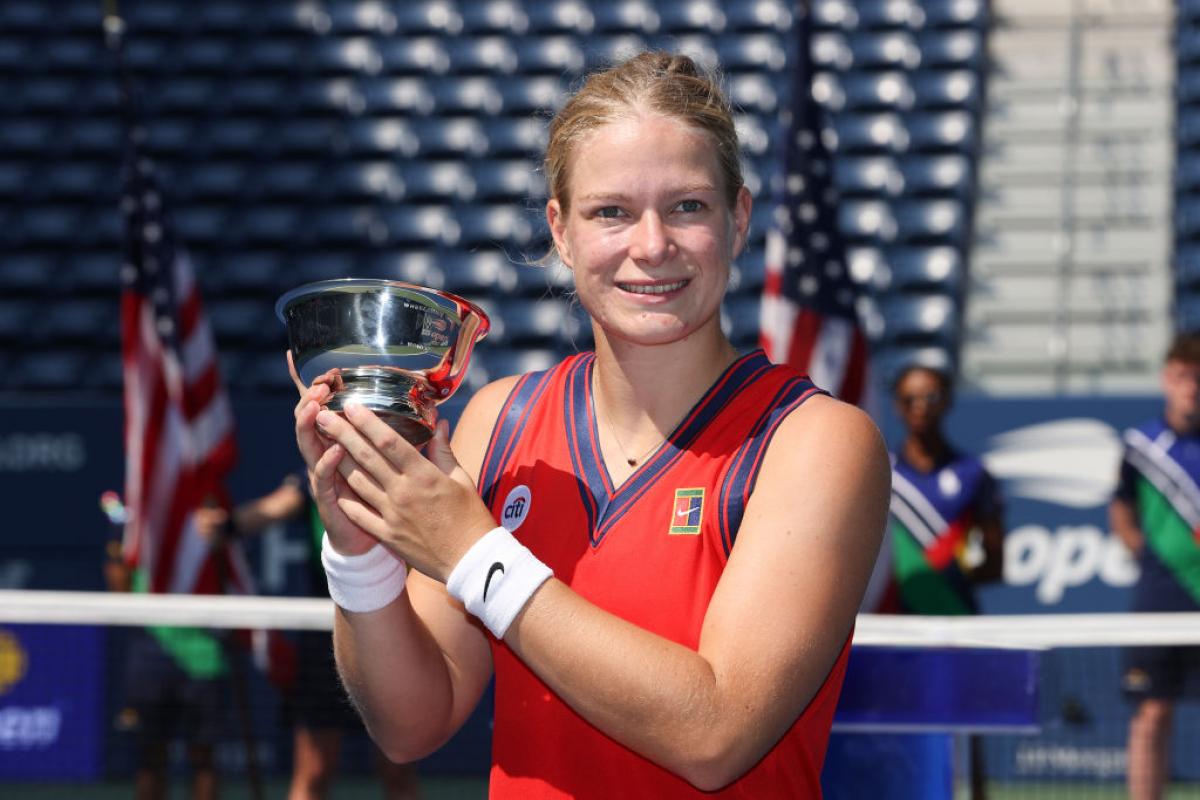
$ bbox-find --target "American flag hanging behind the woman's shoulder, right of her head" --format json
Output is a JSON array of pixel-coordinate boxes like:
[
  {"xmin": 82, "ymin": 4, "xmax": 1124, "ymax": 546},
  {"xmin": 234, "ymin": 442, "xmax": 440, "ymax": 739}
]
[{"xmin": 760, "ymin": 1, "xmax": 868, "ymax": 404}]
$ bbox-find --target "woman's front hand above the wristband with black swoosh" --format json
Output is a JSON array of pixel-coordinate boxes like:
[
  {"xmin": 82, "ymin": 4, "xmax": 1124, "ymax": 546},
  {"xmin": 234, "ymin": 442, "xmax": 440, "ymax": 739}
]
[{"xmin": 317, "ymin": 403, "xmax": 496, "ymax": 582}]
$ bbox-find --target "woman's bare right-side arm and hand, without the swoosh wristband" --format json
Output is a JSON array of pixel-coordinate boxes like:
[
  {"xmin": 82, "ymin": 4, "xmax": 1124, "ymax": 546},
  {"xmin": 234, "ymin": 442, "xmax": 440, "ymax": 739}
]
[{"xmin": 328, "ymin": 398, "xmax": 890, "ymax": 789}]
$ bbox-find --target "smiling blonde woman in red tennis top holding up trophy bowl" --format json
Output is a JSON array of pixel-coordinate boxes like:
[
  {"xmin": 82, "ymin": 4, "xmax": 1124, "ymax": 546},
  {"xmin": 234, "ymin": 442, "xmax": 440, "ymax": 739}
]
[{"xmin": 296, "ymin": 53, "xmax": 888, "ymax": 798}]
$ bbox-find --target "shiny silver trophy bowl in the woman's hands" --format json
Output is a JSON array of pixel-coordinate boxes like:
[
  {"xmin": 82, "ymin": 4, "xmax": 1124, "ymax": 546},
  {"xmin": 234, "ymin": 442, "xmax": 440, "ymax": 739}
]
[{"xmin": 275, "ymin": 278, "xmax": 491, "ymax": 446}]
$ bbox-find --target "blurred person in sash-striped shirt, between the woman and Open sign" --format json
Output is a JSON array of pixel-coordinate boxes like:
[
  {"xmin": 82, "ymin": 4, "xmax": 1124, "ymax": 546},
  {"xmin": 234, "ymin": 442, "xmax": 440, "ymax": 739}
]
[{"xmin": 884, "ymin": 366, "xmax": 1004, "ymax": 800}]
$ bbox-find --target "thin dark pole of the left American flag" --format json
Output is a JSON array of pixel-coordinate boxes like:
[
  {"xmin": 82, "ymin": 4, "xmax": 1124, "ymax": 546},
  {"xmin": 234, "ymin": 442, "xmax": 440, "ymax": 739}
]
[{"xmin": 102, "ymin": 0, "xmax": 264, "ymax": 800}]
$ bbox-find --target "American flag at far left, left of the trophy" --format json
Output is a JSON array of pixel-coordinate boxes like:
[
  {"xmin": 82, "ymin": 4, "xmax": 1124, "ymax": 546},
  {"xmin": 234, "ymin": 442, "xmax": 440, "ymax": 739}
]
[{"xmin": 120, "ymin": 124, "xmax": 248, "ymax": 594}]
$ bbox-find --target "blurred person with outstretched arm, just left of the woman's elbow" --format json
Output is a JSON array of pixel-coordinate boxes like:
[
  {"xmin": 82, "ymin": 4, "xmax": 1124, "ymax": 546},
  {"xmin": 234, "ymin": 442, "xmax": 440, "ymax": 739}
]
[{"xmin": 197, "ymin": 475, "xmax": 420, "ymax": 800}]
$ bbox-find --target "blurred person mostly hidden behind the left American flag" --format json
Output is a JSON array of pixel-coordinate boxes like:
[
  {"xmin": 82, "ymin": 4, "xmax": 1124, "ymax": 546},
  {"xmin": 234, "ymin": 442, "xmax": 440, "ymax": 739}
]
[{"xmin": 101, "ymin": 492, "xmax": 228, "ymax": 800}]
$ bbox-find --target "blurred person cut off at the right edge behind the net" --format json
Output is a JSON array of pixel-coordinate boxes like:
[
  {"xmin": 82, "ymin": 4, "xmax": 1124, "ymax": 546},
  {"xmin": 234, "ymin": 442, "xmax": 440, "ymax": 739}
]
[{"xmin": 1109, "ymin": 333, "xmax": 1200, "ymax": 800}]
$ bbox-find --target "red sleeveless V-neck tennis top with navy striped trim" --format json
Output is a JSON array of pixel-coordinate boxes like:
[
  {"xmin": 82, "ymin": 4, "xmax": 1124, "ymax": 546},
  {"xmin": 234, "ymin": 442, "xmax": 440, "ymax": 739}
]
[{"xmin": 479, "ymin": 351, "xmax": 850, "ymax": 800}]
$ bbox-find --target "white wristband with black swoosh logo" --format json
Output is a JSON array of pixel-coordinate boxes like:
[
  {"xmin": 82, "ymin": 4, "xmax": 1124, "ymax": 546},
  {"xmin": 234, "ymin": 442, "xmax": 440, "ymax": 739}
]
[{"xmin": 446, "ymin": 528, "xmax": 554, "ymax": 639}]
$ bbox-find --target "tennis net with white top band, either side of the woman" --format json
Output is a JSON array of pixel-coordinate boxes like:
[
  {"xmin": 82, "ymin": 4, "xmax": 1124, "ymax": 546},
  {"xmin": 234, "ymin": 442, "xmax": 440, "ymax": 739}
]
[{"xmin": 0, "ymin": 590, "xmax": 1200, "ymax": 800}]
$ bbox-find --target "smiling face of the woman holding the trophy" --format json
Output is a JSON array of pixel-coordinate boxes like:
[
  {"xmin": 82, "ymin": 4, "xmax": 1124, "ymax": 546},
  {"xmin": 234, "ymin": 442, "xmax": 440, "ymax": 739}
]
[{"xmin": 546, "ymin": 115, "xmax": 750, "ymax": 344}]
